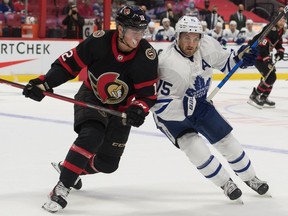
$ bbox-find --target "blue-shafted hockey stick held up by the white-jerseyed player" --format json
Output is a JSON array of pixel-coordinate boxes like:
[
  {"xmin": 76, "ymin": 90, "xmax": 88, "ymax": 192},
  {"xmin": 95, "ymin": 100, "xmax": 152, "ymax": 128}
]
[{"xmin": 207, "ymin": 5, "xmax": 288, "ymax": 101}]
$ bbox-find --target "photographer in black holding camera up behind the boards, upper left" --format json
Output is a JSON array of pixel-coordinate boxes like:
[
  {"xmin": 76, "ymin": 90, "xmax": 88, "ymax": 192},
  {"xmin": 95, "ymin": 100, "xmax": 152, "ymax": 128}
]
[{"xmin": 62, "ymin": 5, "xmax": 84, "ymax": 39}]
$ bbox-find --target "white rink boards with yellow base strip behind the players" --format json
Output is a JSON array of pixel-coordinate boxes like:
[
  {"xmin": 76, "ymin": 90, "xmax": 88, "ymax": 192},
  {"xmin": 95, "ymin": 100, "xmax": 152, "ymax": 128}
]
[{"xmin": 0, "ymin": 39, "xmax": 288, "ymax": 82}]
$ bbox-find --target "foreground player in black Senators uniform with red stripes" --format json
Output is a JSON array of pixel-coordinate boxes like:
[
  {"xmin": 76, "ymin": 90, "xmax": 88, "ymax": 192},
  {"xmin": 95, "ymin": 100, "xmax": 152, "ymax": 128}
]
[{"xmin": 23, "ymin": 6, "xmax": 158, "ymax": 212}]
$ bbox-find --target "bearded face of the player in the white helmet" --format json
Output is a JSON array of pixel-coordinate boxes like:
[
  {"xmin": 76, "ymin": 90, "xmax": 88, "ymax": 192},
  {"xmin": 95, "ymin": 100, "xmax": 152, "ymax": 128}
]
[{"xmin": 178, "ymin": 32, "xmax": 200, "ymax": 57}]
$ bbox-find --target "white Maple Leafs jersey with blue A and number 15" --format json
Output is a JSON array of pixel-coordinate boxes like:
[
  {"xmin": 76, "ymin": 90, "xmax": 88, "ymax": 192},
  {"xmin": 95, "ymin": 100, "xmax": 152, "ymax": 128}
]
[{"xmin": 152, "ymin": 35, "xmax": 236, "ymax": 121}]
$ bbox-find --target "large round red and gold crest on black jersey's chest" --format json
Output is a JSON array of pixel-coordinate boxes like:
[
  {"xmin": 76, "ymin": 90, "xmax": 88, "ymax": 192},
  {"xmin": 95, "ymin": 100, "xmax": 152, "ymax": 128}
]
[{"xmin": 88, "ymin": 71, "xmax": 128, "ymax": 104}]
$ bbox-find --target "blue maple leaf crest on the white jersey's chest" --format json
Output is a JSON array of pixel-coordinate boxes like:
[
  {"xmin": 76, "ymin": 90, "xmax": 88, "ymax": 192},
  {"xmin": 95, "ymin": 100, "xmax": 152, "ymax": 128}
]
[{"xmin": 186, "ymin": 76, "xmax": 211, "ymax": 99}]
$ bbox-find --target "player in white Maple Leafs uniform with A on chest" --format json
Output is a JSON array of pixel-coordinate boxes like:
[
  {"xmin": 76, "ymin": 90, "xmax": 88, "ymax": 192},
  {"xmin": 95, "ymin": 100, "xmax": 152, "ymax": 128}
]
[{"xmin": 152, "ymin": 16, "xmax": 269, "ymax": 200}]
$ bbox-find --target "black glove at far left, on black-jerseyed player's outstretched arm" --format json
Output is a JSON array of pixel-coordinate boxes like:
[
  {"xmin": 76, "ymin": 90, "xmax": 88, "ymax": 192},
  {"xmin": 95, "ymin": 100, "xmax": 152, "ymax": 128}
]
[{"xmin": 23, "ymin": 78, "xmax": 53, "ymax": 101}]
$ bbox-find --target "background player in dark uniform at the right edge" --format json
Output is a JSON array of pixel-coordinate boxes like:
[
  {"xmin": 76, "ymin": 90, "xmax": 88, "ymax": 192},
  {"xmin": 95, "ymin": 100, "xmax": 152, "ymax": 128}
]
[{"xmin": 247, "ymin": 17, "xmax": 286, "ymax": 109}]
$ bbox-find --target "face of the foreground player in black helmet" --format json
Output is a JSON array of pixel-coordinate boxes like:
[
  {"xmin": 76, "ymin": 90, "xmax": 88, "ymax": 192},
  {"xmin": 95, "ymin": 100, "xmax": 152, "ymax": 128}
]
[{"xmin": 119, "ymin": 26, "xmax": 145, "ymax": 52}]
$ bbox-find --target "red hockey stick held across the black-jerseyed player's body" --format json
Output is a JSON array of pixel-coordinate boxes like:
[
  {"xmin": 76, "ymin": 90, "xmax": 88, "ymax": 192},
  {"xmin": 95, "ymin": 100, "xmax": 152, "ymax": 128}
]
[{"xmin": 0, "ymin": 78, "xmax": 126, "ymax": 119}]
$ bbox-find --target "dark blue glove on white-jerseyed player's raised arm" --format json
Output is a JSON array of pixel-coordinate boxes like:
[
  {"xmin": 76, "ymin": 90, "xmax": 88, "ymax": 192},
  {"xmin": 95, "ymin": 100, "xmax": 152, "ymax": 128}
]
[{"xmin": 234, "ymin": 45, "xmax": 258, "ymax": 69}]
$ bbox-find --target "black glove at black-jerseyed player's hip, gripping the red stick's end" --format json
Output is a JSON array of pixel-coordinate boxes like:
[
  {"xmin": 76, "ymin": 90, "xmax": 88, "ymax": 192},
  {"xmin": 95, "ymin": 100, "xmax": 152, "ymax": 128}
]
[{"xmin": 125, "ymin": 105, "xmax": 148, "ymax": 127}]
